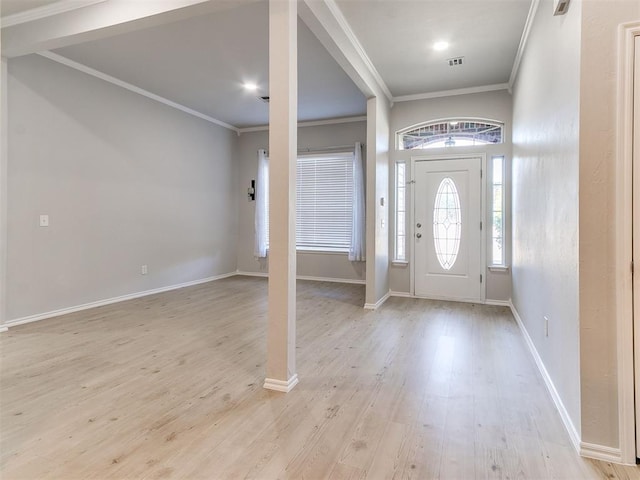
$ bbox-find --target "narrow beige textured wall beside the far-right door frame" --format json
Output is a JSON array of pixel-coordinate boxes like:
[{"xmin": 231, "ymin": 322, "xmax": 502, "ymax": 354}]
[{"xmin": 572, "ymin": 0, "xmax": 640, "ymax": 447}]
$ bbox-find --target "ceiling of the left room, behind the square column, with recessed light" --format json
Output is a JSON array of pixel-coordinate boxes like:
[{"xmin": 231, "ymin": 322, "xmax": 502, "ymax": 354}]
[{"xmin": 55, "ymin": 1, "xmax": 366, "ymax": 128}]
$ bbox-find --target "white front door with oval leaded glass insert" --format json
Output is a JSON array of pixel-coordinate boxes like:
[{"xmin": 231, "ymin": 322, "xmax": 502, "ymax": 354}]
[{"xmin": 413, "ymin": 157, "xmax": 484, "ymax": 301}]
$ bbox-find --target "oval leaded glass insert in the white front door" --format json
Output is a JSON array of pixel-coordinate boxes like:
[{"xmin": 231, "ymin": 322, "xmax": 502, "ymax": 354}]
[{"xmin": 433, "ymin": 177, "xmax": 462, "ymax": 270}]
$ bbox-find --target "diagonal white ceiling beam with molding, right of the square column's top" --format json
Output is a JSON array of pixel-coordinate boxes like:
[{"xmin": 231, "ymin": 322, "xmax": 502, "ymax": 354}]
[{"xmin": 298, "ymin": 0, "xmax": 393, "ymax": 103}]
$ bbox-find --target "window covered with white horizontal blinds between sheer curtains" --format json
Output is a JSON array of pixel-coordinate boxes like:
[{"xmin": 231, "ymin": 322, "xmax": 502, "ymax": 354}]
[{"xmin": 267, "ymin": 152, "xmax": 353, "ymax": 252}]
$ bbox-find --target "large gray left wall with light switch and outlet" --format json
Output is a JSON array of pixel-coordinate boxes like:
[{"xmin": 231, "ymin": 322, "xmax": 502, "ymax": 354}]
[{"xmin": 7, "ymin": 55, "xmax": 238, "ymax": 321}]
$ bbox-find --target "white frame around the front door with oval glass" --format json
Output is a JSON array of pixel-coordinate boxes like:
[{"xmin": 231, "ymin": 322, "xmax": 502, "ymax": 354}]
[{"xmin": 407, "ymin": 152, "xmax": 488, "ymax": 303}]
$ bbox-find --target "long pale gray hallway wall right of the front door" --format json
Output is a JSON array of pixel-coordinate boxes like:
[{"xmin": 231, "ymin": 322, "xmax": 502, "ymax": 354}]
[{"xmin": 512, "ymin": 0, "xmax": 581, "ymax": 434}]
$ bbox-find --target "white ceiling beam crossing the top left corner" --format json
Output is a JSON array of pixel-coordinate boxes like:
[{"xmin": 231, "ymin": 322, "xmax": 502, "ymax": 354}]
[{"xmin": 1, "ymin": 0, "xmax": 256, "ymax": 58}]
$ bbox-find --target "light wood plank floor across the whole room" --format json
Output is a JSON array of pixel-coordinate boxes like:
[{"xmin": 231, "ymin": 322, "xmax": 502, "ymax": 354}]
[{"xmin": 0, "ymin": 277, "xmax": 640, "ymax": 480}]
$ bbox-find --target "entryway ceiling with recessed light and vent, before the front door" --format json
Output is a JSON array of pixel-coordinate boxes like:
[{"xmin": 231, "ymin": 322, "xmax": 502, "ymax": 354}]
[{"xmin": 337, "ymin": 0, "xmax": 531, "ymax": 97}]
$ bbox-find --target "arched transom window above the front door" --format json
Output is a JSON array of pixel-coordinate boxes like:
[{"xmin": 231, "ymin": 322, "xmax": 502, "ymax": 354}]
[{"xmin": 397, "ymin": 118, "xmax": 504, "ymax": 150}]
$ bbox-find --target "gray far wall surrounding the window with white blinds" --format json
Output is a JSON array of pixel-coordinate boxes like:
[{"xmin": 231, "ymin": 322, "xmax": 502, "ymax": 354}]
[{"xmin": 235, "ymin": 121, "xmax": 366, "ymax": 281}]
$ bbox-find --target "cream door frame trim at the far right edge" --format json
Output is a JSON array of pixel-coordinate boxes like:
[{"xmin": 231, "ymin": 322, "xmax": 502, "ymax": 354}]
[{"xmin": 615, "ymin": 22, "xmax": 640, "ymax": 464}]
